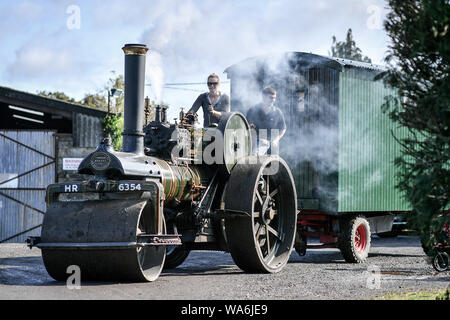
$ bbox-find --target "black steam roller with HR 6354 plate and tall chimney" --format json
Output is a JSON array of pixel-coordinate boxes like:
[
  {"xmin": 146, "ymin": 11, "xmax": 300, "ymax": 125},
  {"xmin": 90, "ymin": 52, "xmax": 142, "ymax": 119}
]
[{"xmin": 28, "ymin": 44, "xmax": 297, "ymax": 281}]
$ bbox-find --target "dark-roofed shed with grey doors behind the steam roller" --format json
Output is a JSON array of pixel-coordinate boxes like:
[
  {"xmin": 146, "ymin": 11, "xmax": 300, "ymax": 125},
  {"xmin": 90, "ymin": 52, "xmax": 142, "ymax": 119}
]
[{"xmin": 0, "ymin": 87, "xmax": 106, "ymax": 243}]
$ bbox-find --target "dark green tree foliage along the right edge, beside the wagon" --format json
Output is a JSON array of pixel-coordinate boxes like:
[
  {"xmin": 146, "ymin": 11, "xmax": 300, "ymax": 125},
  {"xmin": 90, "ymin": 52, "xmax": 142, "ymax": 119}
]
[{"xmin": 384, "ymin": 0, "xmax": 450, "ymax": 250}]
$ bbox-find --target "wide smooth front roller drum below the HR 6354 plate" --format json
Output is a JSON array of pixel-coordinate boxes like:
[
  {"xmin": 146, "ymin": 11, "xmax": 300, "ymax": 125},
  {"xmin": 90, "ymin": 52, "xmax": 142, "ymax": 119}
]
[{"xmin": 41, "ymin": 200, "xmax": 166, "ymax": 281}]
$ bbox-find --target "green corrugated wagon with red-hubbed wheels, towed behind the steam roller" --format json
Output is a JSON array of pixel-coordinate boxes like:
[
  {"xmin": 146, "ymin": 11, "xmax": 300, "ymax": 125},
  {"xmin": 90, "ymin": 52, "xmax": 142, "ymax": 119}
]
[{"xmin": 225, "ymin": 52, "xmax": 410, "ymax": 262}]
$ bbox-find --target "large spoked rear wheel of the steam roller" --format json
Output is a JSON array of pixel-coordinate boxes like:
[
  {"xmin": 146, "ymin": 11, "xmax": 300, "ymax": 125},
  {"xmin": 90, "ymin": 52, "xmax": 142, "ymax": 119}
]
[{"xmin": 225, "ymin": 156, "xmax": 297, "ymax": 273}]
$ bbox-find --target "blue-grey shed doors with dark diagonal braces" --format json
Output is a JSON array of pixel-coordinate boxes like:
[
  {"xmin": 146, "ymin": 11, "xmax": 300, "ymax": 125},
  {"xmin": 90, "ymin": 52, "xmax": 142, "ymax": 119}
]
[{"xmin": 0, "ymin": 130, "xmax": 55, "ymax": 243}]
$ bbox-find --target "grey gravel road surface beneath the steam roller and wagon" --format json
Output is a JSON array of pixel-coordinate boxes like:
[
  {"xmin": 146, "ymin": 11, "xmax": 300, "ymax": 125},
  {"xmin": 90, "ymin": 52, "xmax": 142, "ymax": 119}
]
[{"xmin": 0, "ymin": 236, "xmax": 450, "ymax": 300}]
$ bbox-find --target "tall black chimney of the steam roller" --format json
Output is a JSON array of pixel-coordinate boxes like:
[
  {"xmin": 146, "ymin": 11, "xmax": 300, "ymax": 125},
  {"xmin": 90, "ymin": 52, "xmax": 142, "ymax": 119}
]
[{"xmin": 122, "ymin": 44, "xmax": 148, "ymax": 154}]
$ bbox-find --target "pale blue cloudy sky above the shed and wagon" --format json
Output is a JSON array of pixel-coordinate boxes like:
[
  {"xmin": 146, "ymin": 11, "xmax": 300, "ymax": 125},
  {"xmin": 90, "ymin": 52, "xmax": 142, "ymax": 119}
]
[{"xmin": 0, "ymin": 0, "xmax": 388, "ymax": 119}]
